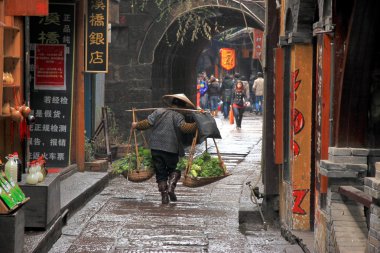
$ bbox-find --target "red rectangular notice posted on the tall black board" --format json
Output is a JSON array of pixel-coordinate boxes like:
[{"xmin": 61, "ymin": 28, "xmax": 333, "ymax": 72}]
[{"xmin": 34, "ymin": 44, "xmax": 66, "ymax": 90}]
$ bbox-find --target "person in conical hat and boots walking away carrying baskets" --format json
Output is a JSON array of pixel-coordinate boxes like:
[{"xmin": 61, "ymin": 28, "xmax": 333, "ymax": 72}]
[{"xmin": 132, "ymin": 94, "xmax": 197, "ymax": 204}]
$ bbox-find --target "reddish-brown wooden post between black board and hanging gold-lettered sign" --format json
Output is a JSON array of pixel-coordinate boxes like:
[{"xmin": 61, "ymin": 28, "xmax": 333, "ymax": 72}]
[{"xmin": 71, "ymin": 0, "xmax": 87, "ymax": 171}]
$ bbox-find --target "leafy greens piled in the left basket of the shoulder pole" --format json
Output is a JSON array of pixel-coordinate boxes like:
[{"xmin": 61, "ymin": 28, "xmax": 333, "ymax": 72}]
[{"xmin": 112, "ymin": 147, "xmax": 153, "ymax": 174}]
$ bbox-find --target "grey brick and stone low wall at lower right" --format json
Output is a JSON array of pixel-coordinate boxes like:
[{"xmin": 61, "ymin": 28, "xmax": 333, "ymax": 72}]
[{"xmin": 314, "ymin": 148, "xmax": 370, "ymax": 252}]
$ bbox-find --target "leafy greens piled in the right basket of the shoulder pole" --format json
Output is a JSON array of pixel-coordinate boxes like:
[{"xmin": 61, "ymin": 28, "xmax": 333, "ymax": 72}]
[{"xmin": 177, "ymin": 152, "xmax": 224, "ymax": 177}]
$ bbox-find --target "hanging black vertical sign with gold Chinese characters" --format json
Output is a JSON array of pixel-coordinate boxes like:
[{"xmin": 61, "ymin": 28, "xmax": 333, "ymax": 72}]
[{"xmin": 85, "ymin": 0, "xmax": 108, "ymax": 73}]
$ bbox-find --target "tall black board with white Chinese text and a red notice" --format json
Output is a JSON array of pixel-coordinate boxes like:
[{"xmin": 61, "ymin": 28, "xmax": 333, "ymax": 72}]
[{"xmin": 29, "ymin": 3, "xmax": 75, "ymax": 167}]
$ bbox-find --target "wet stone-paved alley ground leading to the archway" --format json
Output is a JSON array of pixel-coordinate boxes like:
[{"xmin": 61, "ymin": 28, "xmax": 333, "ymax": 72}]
[{"xmin": 50, "ymin": 113, "xmax": 302, "ymax": 253}]
